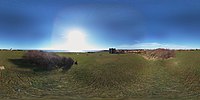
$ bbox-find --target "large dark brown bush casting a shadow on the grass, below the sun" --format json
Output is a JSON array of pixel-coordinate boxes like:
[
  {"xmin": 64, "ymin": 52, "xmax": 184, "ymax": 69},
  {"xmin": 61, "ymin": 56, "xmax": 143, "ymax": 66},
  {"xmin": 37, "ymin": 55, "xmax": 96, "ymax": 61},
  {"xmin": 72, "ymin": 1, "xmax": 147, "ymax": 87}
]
[{"xmin": 24, "ymin": 50, "xmax": 74, "ymax": 70}]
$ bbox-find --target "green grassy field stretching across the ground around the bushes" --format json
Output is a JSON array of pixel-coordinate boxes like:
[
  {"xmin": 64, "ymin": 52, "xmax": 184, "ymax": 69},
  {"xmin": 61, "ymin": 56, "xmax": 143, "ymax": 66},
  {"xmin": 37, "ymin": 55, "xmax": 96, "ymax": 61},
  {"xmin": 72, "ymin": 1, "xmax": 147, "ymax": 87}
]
[{"xmin": 0, "ymin": 51, "xmax": 200, "ymax": 100}]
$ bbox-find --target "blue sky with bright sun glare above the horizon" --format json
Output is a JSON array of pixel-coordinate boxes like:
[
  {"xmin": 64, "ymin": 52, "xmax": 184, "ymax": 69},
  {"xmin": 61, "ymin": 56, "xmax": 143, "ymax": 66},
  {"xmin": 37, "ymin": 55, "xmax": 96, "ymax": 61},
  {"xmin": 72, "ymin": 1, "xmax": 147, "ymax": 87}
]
[{"xmin": 0, "ymin": 0, "xmax": 200, "ymax": 51}]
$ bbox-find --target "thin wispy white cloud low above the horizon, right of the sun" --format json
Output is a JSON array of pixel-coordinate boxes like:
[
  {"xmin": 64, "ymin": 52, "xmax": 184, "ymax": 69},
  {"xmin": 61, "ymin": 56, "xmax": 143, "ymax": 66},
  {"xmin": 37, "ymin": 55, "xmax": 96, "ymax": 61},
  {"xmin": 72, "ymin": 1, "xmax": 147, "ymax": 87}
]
[{"xmin": 117, "ymin": 43, "xmax": 191, "ymax": 49}]
